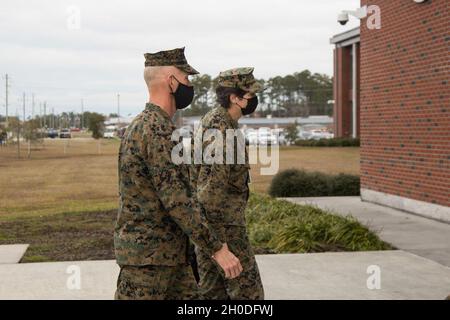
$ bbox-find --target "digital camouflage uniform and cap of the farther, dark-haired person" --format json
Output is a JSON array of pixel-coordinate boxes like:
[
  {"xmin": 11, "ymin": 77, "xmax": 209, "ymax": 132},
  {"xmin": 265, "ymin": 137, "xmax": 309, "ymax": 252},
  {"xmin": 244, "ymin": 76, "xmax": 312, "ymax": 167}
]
[{"xmin": 191, "ymin": 68, "xmax": 264, "ymax": 300}]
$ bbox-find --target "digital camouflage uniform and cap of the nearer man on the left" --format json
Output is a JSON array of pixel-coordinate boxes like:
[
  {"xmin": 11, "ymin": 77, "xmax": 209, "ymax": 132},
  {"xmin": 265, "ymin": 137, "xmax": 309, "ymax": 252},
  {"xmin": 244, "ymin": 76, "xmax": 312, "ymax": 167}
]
[{"xmin": 114, "ymin": 48, "xmax": 222, "ymax": 299}]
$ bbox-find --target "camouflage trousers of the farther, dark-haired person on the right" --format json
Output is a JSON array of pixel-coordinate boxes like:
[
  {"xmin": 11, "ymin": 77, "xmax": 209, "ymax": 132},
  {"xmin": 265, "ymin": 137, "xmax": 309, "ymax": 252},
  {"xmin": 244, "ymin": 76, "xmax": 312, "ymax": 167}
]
[{"xmin": 195, "ymin": 226, "xmax": 264, "ymax": 300}]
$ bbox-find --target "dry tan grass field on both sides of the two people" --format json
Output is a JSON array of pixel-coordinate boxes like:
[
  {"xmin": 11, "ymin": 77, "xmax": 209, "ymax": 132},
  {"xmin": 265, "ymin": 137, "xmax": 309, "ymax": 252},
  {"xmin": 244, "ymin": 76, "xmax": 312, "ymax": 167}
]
[{"xmin": 0, "ymin": 137, "xmax": 359, "ymax": 220}]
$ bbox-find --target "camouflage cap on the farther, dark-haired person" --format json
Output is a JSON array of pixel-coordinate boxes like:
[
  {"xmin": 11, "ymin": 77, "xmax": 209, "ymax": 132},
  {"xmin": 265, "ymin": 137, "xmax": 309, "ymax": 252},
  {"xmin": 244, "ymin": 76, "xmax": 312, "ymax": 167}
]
[{"xmin": 218, "ymin": 67, "xmax": 264, "ymax": 93}]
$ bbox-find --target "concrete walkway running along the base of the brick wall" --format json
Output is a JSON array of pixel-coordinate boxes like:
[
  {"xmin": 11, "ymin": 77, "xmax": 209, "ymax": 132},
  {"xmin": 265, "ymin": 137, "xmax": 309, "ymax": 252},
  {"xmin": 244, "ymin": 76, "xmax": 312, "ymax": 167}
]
[{"xmin": 284, "ymin": 197, "xmax": 450, "ymax": 266}]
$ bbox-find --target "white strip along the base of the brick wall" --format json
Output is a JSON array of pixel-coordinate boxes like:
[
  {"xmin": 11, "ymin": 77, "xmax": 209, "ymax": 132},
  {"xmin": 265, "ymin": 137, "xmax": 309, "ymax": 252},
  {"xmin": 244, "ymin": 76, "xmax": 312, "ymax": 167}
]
[{"xmin": 361, "ymin": 188, "xmax": 450, "ymax": 223}]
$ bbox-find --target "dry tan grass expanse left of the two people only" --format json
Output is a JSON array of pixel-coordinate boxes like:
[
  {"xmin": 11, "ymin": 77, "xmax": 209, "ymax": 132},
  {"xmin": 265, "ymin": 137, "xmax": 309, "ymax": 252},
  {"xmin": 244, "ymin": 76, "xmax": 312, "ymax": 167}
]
[{"xmin": 0, "ymin": 138, "xmax": 118, "ymax": 219}]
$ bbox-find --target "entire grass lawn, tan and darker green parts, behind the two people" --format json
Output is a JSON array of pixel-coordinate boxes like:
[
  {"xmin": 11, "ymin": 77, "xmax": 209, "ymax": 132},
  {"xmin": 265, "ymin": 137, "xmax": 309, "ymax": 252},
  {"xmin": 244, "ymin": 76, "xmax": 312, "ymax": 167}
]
[{"xmin": 0, "ymin": 135, "xmax": 366, "ymax": 262}]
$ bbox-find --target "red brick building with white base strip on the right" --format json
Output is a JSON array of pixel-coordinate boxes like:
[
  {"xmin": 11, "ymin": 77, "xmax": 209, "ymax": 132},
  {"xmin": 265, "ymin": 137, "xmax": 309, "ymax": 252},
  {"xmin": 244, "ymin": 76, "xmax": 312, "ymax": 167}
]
[{"xmin": 331, "ymin": 0, "xmax": 450, "ymax": 222}]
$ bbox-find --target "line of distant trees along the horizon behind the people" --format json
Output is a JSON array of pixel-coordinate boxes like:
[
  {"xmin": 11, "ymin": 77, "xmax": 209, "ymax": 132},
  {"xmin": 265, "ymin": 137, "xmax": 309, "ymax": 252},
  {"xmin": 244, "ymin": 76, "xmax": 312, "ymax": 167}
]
[{"xmin": 0, "ymin": 70, "xmax": 333, "ymax": 145}]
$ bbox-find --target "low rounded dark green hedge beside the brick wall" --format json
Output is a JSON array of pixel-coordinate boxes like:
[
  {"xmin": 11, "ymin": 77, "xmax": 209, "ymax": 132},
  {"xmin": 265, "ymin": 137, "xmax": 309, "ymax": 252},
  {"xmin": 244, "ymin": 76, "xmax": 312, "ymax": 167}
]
[{"xmin": 269, "ymin": 169, "xmax": 360, "ymax": 197}]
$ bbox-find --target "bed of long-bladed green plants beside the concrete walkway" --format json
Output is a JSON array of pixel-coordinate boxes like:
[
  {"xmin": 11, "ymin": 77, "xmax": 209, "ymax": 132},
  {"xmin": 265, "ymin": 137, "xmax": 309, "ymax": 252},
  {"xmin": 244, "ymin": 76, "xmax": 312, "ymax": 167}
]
[{"xmin": 246, "ymin": 194, "xmax": 392, "ymax": 253}]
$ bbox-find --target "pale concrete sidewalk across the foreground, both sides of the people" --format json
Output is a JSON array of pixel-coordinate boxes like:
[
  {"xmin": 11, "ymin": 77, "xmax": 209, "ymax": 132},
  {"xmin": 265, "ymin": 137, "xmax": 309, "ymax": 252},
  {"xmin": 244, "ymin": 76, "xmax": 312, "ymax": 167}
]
[{"xmin": 0, "ymin": 250, "xmax": 450, "ymax": 300}]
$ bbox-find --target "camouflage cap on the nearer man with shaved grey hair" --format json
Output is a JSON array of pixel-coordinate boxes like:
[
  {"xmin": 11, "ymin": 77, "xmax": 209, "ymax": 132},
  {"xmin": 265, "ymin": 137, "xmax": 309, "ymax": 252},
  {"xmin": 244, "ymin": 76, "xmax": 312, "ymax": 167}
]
[{"xmin": 144, "ymin": 47, "xmax": 199, "ymax": 74}]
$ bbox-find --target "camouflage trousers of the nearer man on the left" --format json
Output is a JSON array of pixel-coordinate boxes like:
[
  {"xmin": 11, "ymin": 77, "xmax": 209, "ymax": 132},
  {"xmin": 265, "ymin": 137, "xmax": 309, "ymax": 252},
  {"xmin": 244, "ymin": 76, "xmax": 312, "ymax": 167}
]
[{"xmin": 115, "ymin": 265, "xmax": 200, "ymax": 300}]
